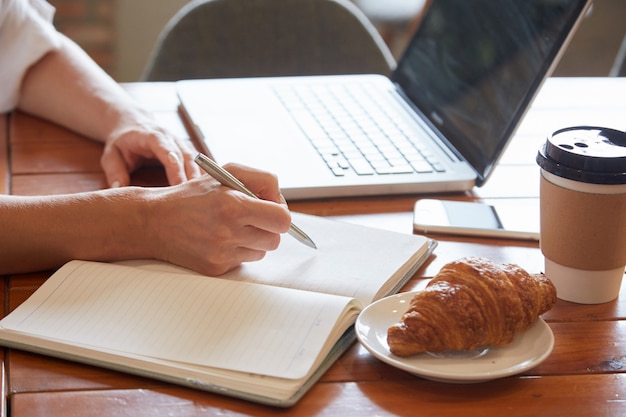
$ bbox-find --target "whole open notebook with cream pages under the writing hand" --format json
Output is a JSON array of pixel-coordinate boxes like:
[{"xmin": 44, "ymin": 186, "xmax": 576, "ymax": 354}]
[{"xmin": 0, "ymin": 214, "xmax": 435, "ymax": 406}]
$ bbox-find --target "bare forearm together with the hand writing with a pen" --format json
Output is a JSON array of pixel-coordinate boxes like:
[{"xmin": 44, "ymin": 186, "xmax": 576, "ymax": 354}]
[{"xmin": 0, "ymin": 166, "xmax": 291, "ymax": 275}]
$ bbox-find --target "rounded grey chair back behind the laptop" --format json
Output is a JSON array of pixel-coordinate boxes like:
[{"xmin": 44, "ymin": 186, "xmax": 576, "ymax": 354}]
[{"xmin": 142, "ymin": 0, "xmax": 395, "ymax": 81}]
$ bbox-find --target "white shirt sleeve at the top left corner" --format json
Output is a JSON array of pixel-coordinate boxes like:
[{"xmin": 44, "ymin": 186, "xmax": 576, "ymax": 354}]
[{"xmin": 0, "ymin": 0, "xmax": 61, "ymax": 113}]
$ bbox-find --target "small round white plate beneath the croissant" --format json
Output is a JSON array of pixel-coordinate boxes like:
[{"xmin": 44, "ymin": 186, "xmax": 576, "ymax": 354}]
[{"xmin": 355, "ymin": 292, "xmax": 554, "ymax": 383}]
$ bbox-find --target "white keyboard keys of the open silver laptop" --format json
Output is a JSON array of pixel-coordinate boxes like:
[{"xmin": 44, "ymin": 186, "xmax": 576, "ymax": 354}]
[{"xmin": 275, "ymin": 84, "xmax": 445, "ymax": 176}]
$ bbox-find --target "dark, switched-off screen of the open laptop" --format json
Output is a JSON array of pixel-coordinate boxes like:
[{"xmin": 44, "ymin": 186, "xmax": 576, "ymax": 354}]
[{"xmin": 392, "ymin": 0, "xmax": 587, "ymax": 185}]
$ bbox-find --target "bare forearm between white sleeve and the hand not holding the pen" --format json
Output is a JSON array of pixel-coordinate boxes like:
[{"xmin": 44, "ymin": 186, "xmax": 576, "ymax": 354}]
[{"xmin": 18, "ymin": 33, "xmax": 148, "ymax": 141}]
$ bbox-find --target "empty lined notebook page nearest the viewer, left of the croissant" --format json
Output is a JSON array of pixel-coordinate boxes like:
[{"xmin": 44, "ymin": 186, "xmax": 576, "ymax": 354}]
[{"xmin": 2, "ymin": 261, "xmax": 357, "ymax": 378}]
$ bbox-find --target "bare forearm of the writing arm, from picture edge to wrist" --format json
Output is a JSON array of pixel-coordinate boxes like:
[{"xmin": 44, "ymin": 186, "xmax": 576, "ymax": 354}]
[{"xmin": 0, "ymin": 188, "xmax": 149, "ymax": 273}]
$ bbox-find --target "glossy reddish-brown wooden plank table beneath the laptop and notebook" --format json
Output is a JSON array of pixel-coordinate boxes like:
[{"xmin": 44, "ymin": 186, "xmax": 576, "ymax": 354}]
[{"xmin": 0, "ymin": 78, "xmax": 626, "ymax": 417}]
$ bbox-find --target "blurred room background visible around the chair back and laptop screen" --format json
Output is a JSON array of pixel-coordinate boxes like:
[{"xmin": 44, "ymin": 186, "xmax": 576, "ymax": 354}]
[{"xmin": 49, "ymin": 0, "xmax": 626, "ymax": 82}]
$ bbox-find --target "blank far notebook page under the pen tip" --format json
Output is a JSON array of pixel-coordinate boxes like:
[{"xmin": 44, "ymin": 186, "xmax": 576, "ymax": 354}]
[{"xmin": 128, "ymin": 213, "xmax": 434, "ymax": 305}]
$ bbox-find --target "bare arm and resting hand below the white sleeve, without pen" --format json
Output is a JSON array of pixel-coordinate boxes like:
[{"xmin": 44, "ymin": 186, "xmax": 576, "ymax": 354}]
[{"xmin": 18, "ymin": 33, "xmax": 199, "ymax": 186}]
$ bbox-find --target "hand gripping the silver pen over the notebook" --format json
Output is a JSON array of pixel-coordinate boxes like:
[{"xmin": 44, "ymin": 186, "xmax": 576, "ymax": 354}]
[{"xmin": 145, "ymin": 164, "xmax": 291, "ymax": 275}]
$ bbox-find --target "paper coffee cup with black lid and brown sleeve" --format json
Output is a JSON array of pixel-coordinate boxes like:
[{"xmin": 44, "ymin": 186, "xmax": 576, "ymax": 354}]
[{"xmin": 537, "ymin": 126, "xmax": 626, "ymax": 304}]
